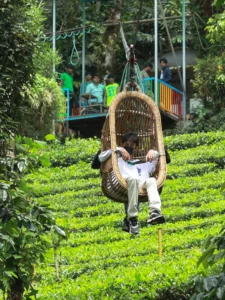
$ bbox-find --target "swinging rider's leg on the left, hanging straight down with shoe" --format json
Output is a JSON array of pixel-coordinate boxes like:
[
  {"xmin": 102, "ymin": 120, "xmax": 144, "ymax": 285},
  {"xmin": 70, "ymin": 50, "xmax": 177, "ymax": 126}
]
[{"xmin": 127, "ymin": 178, "xmax": 139, "ymax": 234}]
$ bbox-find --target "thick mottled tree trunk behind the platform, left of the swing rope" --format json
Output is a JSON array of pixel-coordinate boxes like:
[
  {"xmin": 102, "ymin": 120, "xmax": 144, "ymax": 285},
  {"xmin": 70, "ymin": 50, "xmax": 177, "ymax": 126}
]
[{"xmin": 103, "ymin": 0, "xmax": 123, "ymax": 73}]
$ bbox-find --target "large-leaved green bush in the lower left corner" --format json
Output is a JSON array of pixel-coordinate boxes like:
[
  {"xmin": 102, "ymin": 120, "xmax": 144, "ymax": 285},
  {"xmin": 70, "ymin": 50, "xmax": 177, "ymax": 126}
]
[{"xmin": 0, "ymin": 136, "xmax": 65, "ymax": 299}]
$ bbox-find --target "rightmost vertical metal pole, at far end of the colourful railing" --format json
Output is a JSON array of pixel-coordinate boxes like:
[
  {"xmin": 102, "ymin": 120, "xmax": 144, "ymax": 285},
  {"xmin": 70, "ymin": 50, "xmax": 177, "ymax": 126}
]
[{"xmin": 182, "ymin": 0, "xmax": 187, "ymax": 121}]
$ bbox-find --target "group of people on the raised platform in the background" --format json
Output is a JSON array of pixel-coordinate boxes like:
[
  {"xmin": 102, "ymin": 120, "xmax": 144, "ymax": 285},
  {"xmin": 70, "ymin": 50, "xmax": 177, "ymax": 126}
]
[{"xmin": 60, "ymin": 58, "xmax": 172, "ymax": 115}]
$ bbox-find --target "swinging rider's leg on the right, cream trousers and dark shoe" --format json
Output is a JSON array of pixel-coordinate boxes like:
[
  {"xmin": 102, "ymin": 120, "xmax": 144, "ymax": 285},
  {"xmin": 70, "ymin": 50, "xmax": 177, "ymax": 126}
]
[{"xmin": 143, "ymin": 177, "xmax": 165, "ymax": 225}]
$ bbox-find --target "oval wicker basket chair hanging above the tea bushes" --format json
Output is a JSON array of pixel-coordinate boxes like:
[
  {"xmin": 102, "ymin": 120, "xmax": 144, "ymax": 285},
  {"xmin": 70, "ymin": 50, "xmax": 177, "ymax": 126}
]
[{"xmin": 101, "ymin": 85, "xmax": 166, "ymax": 202}]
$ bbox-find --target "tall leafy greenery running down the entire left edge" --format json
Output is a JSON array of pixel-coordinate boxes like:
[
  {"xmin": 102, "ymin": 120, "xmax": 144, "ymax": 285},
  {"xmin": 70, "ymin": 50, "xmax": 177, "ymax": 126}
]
[{"xmin": 0, "ymin": 0, "xmax": 65, "ymax": 300}]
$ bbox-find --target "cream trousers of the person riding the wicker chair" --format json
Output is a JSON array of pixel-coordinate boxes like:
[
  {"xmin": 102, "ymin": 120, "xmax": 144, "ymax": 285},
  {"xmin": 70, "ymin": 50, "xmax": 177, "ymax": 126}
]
[{"xmin": 127, "ymin": 177, "xmax": 161, "ymax": 219}]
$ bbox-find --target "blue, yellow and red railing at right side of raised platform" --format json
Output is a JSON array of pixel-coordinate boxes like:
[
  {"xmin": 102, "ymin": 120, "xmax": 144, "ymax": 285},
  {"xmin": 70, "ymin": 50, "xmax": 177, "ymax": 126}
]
[{"xmin": 143, "ymin": 77, "xmax": 184, "ymax": 119}]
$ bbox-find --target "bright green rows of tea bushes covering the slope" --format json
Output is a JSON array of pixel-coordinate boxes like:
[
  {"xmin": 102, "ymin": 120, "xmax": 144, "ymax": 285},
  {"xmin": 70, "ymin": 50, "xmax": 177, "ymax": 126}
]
[{"xmin": 24, "ymin": 132, "xmax": 225, "ymax": 300}]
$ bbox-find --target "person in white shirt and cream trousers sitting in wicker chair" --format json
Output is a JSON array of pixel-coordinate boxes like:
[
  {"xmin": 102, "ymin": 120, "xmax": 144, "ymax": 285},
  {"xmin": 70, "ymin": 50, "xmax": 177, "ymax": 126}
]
[{"xmin": 98, "ymin": 132, "xmax": 165, "ymax": 234}]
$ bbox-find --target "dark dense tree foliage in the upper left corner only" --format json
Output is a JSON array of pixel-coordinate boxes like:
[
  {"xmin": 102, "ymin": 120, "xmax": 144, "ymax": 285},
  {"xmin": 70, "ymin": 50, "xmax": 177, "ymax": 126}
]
[{"xmin": 0, "ymin": 0, "xmax": 43, "ymax": 121}]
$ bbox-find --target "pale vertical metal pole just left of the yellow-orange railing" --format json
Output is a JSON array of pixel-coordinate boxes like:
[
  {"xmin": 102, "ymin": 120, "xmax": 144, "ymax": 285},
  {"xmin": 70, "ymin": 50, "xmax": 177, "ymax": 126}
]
[{"xmin": 154, "ymin": 0, "xmax": 159, "ymax": 106}]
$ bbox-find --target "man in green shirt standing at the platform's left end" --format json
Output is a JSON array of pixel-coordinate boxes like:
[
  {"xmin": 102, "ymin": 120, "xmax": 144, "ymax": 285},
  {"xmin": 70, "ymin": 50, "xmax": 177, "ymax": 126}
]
[{"xmin": 60, "ymin": 65, "xmax": 79, "ymax": 116}]
